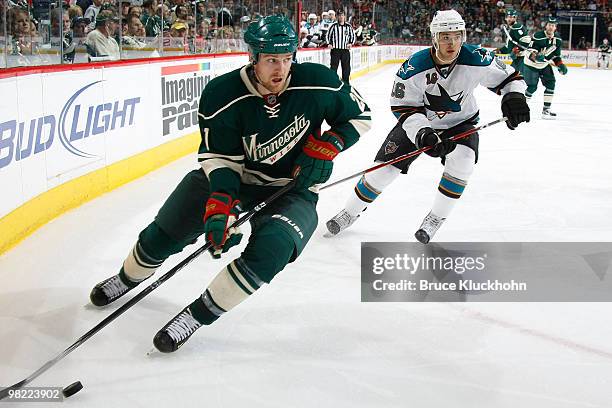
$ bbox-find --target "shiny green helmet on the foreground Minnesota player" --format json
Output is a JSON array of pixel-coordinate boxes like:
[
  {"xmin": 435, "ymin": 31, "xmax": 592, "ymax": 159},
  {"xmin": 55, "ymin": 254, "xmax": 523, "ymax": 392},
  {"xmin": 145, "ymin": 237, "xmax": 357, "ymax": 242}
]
[{"xmin": 244, "ymin": 15, "xmax": 298, "ymax": 62}]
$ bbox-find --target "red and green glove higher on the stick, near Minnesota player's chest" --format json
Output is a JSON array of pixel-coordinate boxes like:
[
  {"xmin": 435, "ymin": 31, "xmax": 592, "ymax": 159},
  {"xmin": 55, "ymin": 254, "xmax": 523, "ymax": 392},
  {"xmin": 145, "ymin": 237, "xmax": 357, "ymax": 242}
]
[{"xmin": 292, "ymin": 131, "xmax": 344, "ymax": 190}]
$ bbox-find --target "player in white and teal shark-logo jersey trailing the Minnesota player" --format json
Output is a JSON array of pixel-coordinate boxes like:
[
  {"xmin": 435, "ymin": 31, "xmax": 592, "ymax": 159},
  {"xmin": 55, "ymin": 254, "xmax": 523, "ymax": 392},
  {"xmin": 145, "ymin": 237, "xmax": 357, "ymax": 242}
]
[{"xmin": 326, "ymin": 10, "xmax": 529, "ymax": 243}]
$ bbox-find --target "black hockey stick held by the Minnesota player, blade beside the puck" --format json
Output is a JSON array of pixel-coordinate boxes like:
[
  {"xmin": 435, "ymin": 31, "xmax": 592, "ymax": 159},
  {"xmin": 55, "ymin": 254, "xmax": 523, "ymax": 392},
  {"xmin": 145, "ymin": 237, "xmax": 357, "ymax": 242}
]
[{"xmin": 0, "ymin": 181, "xmax": 295, "ymax": 400}]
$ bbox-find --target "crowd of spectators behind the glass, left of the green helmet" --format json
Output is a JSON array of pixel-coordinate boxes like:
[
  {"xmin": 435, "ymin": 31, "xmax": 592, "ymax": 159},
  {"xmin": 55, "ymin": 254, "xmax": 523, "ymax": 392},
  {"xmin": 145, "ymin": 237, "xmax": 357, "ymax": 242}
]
[{"xmin": 0, "ymin": 0, "xmax": 290, "ymax": 65}]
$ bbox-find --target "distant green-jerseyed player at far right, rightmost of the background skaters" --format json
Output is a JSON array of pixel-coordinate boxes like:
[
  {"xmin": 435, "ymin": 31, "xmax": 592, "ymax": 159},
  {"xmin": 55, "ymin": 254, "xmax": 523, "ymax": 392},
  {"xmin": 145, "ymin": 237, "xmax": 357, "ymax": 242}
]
[{"xmin": 523, "ymin": 17, "xmax": 567, "ymax": 119}]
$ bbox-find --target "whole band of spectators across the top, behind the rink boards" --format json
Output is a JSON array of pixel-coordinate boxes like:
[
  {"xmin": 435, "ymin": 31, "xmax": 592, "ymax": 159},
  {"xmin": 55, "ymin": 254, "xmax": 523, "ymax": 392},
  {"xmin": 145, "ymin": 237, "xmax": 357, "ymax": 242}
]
[{"xmin": 0, "ymin": 0, "xmax": 612, "ymax": 66}]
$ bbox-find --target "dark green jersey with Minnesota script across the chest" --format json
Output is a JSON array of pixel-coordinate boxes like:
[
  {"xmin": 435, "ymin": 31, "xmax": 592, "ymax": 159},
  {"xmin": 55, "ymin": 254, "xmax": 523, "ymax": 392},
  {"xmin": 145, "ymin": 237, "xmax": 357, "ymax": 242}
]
[{"xmin": 198, "ymin": 63, "xmax": 371, "ymax": 197}]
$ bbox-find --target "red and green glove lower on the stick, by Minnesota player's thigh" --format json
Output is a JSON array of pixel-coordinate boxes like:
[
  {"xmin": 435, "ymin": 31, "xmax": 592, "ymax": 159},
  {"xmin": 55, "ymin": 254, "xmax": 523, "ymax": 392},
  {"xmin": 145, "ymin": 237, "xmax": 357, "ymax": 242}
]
[{"xmin": 204, "ymin": 193, "xmax": 242, "ymax": 258}]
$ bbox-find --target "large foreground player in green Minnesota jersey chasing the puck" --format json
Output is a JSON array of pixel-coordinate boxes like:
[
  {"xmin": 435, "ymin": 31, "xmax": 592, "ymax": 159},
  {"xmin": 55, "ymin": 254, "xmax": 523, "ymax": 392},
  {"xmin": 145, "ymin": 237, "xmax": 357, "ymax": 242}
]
[{"xmin": 90, "ymin": 16, "xmax": 370, "ymax": 352}]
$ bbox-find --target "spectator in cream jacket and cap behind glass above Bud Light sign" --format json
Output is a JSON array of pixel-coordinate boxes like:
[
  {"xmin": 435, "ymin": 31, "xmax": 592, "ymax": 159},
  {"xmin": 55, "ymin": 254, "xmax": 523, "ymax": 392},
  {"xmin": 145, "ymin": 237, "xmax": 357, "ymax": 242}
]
[{"xmin": 85, "ymin": 10, "xmax": 120, "ymax": 61}]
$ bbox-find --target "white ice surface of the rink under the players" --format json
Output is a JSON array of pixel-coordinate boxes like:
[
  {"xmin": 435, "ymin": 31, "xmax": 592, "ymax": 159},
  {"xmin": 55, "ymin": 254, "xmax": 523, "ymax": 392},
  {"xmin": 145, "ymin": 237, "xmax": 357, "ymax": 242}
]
[{"xmin": 0, "ymin": 66, "xmax": 612, "ymax": 408}]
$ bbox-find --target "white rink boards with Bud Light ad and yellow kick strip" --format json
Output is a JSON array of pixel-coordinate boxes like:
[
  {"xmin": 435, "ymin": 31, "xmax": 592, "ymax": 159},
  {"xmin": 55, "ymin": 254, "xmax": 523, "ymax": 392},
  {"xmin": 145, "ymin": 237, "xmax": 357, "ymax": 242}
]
[{"xmin": 0, "ymin": 46, "xmax": 418, "ymax": 254}]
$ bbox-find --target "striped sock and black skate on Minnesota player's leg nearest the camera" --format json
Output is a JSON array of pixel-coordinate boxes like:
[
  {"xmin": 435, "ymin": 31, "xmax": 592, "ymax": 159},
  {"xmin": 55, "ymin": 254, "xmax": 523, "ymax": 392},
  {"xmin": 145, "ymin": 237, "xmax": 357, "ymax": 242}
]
[{"xmin": 153, "ymin": 258, "xmax": 264, "ymax": 353}]
